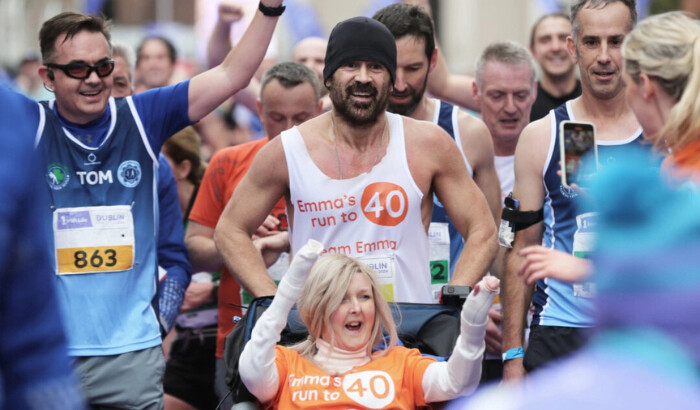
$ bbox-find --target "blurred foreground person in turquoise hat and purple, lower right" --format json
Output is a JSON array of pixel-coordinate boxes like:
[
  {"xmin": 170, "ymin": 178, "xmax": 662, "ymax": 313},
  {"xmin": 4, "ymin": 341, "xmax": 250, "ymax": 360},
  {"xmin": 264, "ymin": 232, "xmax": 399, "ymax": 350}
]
[{"xmin": 453, "ymin": 149, "xmax": 700, "ymax": 410}]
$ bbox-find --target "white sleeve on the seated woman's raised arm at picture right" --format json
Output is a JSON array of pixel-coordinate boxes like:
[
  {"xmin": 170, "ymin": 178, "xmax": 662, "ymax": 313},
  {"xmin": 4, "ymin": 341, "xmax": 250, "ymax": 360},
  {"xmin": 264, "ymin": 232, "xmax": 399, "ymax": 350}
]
[{"xmin": 422, "ymin": 279, "xmax": 498, "ymax": 403}]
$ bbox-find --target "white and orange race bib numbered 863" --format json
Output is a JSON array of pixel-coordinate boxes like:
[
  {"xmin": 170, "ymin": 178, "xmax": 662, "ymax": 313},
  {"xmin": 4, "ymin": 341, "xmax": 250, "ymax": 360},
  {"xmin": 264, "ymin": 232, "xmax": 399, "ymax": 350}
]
[{"xmin": 53, "ymin": 205, "xmax": 134, "ymax": 275}]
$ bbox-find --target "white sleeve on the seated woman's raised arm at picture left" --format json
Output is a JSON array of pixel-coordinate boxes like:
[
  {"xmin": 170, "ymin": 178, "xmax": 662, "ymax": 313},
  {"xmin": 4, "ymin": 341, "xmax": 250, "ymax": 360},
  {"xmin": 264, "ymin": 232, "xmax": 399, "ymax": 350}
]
[{"xmin": 238, "ymin": 239, "xmax": 323, "ymax": 403}]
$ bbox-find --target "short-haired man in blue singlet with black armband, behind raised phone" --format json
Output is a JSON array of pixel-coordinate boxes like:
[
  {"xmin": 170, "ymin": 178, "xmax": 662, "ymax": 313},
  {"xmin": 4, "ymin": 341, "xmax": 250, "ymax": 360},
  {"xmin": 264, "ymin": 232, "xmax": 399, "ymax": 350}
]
[{"xmin": 501, "ymin": 0, "xmax": 642, "ymax": 379}]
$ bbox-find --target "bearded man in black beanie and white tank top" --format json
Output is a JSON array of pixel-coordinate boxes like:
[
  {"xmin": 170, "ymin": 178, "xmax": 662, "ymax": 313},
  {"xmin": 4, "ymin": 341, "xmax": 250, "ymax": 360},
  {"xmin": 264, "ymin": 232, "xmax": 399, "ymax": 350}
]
[{"xmin": 214, "ymin": 17, "xmax": 498, "ymax": 303}]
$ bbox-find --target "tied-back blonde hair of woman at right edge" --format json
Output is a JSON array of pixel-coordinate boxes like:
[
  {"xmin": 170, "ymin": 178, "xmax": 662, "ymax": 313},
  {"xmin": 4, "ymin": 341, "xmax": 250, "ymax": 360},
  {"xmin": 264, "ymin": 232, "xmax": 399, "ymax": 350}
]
[{"xmin": 622, "ymin": 11, "xmax": 700, "ymax": 151}]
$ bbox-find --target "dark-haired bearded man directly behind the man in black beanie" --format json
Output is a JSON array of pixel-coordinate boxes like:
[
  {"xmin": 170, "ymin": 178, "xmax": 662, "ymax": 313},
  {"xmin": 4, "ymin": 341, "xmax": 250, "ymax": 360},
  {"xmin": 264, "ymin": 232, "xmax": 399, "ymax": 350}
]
[{"xmin": 373, "ymin": 3, "xmax": 501, "ymax": 292}]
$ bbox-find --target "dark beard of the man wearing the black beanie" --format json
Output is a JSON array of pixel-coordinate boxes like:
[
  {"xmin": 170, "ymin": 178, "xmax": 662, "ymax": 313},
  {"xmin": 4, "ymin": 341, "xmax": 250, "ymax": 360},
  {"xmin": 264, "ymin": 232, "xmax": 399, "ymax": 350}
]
[{"xmin": 330, "ymin": 78, "xmax": 390, "ymax": 127}]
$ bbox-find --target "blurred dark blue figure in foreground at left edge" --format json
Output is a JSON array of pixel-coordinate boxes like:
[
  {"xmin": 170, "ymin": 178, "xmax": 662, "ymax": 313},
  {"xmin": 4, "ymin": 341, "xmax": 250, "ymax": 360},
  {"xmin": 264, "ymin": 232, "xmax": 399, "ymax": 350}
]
[{"xmin": 0, "ymin": 86, "xmax": 85, "ymax": 410}]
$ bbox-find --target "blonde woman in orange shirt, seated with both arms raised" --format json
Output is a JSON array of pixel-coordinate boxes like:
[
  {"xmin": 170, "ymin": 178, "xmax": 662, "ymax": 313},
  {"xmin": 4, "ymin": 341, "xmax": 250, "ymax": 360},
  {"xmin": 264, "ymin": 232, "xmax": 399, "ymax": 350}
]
[{"xmin": 239, "ymin": 241, "xmax": 499, "ymax": 409}]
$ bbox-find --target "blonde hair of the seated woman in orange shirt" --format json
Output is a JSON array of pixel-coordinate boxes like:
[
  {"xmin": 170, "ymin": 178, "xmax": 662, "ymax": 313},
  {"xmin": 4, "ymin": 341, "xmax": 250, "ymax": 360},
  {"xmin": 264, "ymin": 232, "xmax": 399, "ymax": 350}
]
[{"xmin": 291, "ymin": 254, "xmax": 398, "ymax": 359}]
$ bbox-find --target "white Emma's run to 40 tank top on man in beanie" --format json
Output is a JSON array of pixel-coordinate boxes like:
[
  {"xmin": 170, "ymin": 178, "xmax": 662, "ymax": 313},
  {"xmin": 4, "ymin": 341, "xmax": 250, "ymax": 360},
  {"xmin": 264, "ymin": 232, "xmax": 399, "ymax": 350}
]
[{"xmin": 281, "ymin": 113, "xmax": 433, "ymax": 303}]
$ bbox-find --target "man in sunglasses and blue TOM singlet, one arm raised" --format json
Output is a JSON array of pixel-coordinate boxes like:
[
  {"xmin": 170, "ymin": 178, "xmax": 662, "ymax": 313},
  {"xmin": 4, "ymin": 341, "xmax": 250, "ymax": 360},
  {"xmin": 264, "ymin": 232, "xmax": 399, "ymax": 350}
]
[{"xmin": 11, "ymin": 0, "xmax": 283, "ymax": 408}]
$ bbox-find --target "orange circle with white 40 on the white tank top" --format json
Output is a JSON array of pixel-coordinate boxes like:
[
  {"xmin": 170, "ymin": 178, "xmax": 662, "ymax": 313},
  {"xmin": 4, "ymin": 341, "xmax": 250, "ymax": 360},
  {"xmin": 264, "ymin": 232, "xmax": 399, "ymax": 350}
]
[{"xmin": 361, "ymin": 182, "xmax": 408, "ymax": 226}]
